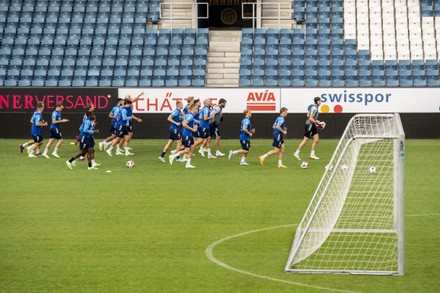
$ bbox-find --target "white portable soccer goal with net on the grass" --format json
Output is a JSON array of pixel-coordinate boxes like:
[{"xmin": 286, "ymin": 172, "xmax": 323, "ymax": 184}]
[{"xmin": 285, "ymin": 114, "xmax": 405, "ymax": 275}]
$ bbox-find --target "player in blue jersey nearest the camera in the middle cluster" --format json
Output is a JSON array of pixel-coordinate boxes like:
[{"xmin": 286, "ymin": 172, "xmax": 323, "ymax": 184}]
[{"xmin": 169, "ymin": 105, "xmax": 198, "ymax": 169}]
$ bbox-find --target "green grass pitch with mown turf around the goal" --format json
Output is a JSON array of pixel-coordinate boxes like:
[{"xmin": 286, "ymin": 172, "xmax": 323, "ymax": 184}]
[{"xmin": 0, "ymin": 139, "xmax": 440, "ymax": 293}]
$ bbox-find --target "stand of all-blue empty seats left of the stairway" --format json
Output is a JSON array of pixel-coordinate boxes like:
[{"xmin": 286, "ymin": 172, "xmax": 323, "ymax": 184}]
[{"xmin": 0, "ymin": 0, "xmax": 209, "ymax": 87}]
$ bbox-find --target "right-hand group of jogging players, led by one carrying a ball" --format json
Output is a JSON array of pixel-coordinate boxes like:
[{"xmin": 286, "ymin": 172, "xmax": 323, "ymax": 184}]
[{"xmin": 159, "ymin": 97, "xmax": 323, "ymax": 169}]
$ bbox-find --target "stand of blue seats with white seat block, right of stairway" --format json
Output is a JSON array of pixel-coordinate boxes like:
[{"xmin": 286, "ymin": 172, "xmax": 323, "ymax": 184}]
[{"xmin": 239, "ymin": 0, "xmax": 440, "ymax": 87}]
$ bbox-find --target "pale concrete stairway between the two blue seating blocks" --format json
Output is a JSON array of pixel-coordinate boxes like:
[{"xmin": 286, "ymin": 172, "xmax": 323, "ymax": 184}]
[{"xmin": 205, "ymin": 31, "xmax": 241, "ymax": 87}]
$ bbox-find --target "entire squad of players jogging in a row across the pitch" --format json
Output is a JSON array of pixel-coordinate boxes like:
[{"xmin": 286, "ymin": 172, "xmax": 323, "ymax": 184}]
[{"xmin": 20, "ymin": 93, "xmax": 322, "ymax": 170}]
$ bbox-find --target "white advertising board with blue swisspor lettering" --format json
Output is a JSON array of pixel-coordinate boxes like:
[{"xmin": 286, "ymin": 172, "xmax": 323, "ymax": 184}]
[{"xmin": 281, "ymin": 88, "xmax": 440, "ymax": 113}]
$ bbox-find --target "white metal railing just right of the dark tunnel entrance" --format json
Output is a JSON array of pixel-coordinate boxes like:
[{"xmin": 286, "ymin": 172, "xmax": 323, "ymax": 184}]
[{"xmin": 241, "ymin": 2, "xmax": 292, "ymax": 29}]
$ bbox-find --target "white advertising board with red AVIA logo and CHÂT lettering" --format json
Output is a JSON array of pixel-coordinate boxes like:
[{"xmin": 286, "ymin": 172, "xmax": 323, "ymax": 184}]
[{"xmin": 119, "ymin": 88, "xmax": 280, "ymax": 113}]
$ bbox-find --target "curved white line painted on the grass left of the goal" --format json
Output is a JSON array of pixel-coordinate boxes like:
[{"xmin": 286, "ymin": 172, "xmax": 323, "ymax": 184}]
[{"xmin": 205, "ymin": 224, "xmax": 356, "ymax": 292}]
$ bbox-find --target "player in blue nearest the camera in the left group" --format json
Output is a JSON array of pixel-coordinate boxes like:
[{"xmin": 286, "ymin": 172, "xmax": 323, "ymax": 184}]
[{"xmin": 66, "ymin": 111, "xmax": 100, "ymax": 170}]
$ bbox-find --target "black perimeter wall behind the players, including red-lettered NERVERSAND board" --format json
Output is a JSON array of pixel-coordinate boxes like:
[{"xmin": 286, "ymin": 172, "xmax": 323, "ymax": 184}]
[{"xmin": 0, "ymin": 88, "xmax": 440, "ymax": 139}]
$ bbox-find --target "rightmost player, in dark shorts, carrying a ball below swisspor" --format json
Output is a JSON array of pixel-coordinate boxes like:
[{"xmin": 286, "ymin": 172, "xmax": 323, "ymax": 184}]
[{"xmin": 293, "ymin": 97, "xmax": 321, "ymax": 161}]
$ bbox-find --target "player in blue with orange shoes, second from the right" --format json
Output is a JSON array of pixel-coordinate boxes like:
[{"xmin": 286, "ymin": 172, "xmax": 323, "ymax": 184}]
[{"xmin": 259, "ymin": 107, "xmax": 287, "ymax": 168}]
